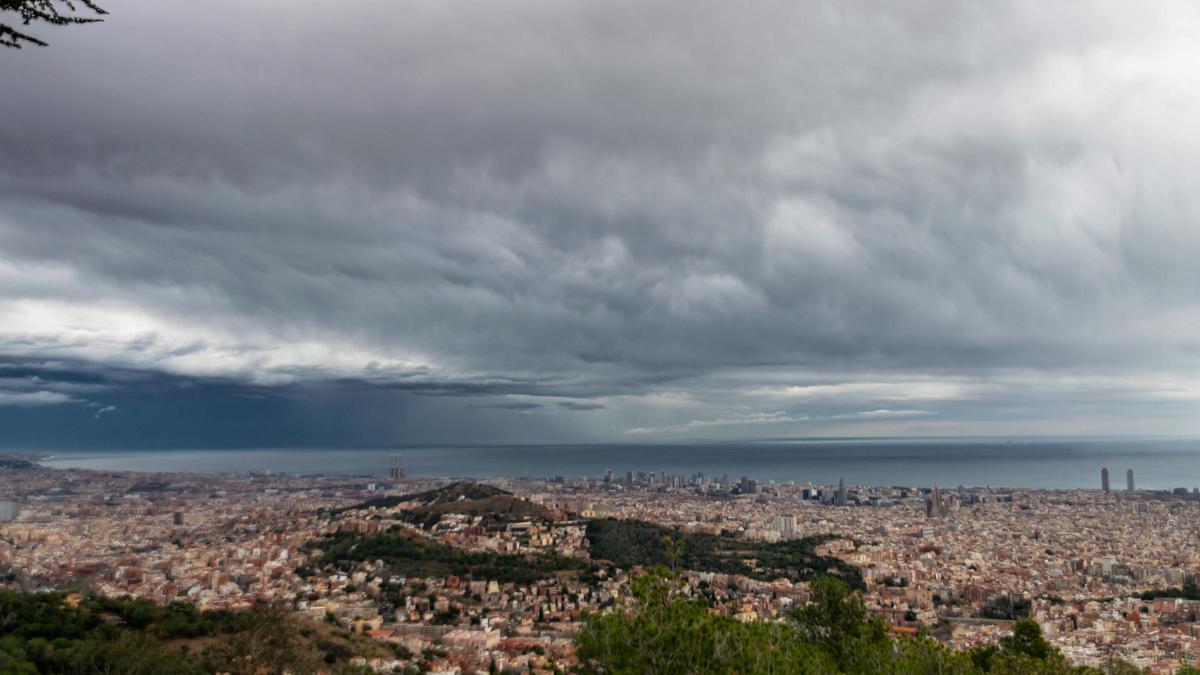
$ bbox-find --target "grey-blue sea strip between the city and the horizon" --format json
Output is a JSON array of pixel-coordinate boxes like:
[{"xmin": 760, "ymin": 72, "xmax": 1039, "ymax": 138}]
[{"xmin": 28, "ymin": 438, "xmax": 1200, "ymax": 490}]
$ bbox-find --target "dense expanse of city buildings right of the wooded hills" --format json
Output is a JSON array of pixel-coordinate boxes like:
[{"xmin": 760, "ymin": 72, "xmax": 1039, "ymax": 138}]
[{"xmin": 511, "ymin": 472, "xmax": 1200, "ymax": 673}]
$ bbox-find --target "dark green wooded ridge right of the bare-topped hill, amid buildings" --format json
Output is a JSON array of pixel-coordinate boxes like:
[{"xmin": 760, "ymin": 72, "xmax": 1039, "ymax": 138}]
[{"xmin": 587, "ymin": 518, "xmax": 863, "ymax": 589}]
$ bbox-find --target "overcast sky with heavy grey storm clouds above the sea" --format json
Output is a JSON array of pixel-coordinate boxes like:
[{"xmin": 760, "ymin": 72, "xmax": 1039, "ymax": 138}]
[{"xmin": 0, "ymin": 0, "xmax": 1200, "ymax": 447}]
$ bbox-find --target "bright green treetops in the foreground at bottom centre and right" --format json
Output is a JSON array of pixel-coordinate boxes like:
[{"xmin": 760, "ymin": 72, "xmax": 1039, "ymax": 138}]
[{"xmin": 576, "ymin": 568, "xmax": 1185, "ymax": 675}]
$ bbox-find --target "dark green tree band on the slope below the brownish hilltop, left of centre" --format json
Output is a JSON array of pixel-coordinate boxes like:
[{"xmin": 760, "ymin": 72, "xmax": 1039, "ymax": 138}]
[{"xmin": 304, "ymin": 530, "xmax": 587, "ymax": 584}]
